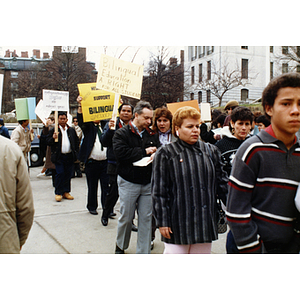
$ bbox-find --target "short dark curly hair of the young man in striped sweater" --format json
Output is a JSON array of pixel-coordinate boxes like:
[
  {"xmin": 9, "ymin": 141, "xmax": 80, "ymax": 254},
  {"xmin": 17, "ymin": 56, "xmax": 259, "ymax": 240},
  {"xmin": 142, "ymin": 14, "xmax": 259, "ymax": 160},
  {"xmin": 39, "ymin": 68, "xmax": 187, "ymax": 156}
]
[{"xmin": 262, "ymin": 73, "xmax": 300, "ymax": 111}]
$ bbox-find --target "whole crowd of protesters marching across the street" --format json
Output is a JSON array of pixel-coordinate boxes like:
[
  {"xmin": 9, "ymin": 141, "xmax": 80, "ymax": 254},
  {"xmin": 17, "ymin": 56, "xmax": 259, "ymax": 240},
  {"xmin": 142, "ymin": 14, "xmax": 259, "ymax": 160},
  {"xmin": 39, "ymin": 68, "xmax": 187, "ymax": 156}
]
[{"xmin": 0, "ymin": 73, "xmax": 300, "ymax": 254}]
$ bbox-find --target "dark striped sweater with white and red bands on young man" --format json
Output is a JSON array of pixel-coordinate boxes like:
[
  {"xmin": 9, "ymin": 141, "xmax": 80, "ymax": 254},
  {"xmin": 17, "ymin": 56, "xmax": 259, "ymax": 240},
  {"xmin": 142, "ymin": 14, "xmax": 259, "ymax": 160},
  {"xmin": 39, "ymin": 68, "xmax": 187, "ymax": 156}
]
[{"xmin": 226, "ymin": 126, "xmax": 300, "ymax": 253}]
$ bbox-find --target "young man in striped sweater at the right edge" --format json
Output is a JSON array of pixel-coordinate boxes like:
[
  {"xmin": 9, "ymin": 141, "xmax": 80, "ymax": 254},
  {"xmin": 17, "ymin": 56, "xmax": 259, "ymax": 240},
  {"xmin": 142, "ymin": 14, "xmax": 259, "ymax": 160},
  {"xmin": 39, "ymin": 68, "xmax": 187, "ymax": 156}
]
[{"xmin": 226, "ymin": 73, "xmax": 300, "ymax": 253}]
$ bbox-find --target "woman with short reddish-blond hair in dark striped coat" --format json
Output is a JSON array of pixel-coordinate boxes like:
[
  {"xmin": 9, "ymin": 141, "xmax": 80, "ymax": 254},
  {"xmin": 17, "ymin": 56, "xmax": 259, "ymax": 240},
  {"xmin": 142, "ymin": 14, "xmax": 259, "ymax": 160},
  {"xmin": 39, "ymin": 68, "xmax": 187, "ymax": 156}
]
[{"xmin": 152, "ymin": 106, "xmax": 228, "ymax": 254}]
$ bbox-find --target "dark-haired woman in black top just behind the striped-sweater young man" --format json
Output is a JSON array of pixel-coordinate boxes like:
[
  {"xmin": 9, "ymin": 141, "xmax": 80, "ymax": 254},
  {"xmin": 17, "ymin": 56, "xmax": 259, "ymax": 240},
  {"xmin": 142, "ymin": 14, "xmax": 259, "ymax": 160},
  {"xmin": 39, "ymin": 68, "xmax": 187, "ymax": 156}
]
[{"xmin": 215, "ymin": 106, "xmax": 253, "ymax": 254}]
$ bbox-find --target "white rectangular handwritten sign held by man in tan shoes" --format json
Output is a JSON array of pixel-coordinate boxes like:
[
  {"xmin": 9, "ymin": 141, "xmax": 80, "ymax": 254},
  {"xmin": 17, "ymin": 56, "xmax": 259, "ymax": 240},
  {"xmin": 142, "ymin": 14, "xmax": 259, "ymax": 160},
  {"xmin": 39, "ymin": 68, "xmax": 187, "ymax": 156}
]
[{"xmin": 43, "ymin": 90, "xmax": 69, "ymax": 112}]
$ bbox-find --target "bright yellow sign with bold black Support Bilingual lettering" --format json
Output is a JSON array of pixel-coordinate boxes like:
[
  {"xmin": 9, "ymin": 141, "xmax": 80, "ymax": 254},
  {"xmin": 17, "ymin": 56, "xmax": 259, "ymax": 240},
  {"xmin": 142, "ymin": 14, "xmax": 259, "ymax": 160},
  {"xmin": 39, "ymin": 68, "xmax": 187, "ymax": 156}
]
[{"xmin": 77, "ymin": 82, "xmax": 120, "ymax": 122}]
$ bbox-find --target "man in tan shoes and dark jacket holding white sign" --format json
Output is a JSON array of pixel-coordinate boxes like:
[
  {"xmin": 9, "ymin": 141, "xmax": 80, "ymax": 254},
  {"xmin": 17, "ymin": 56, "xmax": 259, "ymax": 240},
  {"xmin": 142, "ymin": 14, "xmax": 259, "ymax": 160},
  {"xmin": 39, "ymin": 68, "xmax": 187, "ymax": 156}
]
[{"xmin": 47, "ymin": 112, "xmax": 79, "ymax": 202}]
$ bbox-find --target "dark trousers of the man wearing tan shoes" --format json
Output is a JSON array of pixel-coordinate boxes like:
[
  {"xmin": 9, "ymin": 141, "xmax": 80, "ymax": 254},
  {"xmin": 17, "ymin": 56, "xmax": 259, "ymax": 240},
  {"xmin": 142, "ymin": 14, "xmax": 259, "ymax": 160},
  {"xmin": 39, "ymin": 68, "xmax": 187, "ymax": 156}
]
[{"xmin": 55, "ymin": 153, "xmax": 74, "ymax": 195}]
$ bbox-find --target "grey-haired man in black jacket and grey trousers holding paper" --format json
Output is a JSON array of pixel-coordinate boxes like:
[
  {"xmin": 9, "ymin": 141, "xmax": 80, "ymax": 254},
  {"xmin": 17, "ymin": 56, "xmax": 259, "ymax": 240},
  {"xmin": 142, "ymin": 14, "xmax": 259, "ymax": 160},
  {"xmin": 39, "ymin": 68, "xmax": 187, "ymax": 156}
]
[{"xmin": 113, "ymin": 101, "xmax": 160, "ymax": 254}]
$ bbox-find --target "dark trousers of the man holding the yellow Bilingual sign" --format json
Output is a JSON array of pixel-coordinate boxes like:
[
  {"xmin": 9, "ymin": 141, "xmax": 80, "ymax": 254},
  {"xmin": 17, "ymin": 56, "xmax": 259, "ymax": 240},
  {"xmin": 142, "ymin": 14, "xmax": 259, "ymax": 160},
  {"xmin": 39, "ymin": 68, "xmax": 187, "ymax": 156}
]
[{"xmin": 85, "ymin": 159, "xmax": 108, "ymax": 211}]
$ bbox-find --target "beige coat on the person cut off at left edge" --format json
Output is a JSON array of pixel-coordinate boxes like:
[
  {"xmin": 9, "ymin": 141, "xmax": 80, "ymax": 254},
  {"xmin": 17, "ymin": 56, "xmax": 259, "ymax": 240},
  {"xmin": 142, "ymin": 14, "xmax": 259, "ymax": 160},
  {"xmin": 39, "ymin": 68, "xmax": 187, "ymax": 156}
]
[{"xmin": 0, "ymin": 136, "xmax": 34, "ymax": 253}]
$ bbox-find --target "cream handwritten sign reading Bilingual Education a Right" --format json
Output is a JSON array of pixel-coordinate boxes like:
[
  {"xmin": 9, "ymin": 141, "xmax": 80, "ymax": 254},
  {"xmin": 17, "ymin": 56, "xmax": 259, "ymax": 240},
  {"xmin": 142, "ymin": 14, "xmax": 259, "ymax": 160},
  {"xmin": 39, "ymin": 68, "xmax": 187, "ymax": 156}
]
[{"xmin": 96, "ymin": 54, "xmax": 144, "ymax": 99}]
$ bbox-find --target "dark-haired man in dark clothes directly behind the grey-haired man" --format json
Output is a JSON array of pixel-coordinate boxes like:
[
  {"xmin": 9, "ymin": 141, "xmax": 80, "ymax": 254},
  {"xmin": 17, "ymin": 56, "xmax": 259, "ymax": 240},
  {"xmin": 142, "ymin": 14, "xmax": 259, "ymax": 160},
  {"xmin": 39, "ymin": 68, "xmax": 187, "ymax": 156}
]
[{"xmin": 100, "ymin": 103, "xmax": 133, "ymax": 226}]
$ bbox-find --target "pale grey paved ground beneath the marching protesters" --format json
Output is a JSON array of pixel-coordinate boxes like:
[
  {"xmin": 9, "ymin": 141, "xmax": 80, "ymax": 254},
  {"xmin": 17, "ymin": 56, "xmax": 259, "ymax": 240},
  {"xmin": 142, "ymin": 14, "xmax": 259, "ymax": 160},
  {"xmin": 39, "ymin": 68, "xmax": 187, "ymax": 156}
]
[{"xmin": 21, "ymin": 167, "xmax": 226, "ymax": 254}]
